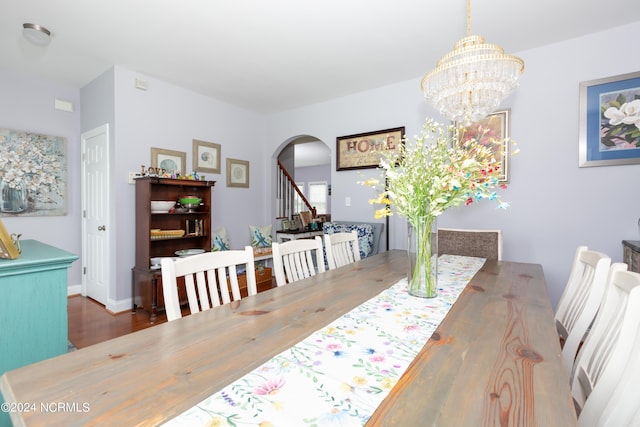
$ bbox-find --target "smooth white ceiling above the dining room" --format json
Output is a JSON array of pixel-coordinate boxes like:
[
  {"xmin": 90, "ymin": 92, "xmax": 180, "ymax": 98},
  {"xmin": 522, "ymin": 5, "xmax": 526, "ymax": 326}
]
[{"xmin": 0, "ymin": 0, "xmax": 640, "ymax": 113}]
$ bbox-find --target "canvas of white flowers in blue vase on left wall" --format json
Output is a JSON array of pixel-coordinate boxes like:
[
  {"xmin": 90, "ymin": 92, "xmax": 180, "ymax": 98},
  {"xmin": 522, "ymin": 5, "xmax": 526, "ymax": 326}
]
[{"xmin": 0, "ymin": 129, "xmax": 67, "ymax": 216}]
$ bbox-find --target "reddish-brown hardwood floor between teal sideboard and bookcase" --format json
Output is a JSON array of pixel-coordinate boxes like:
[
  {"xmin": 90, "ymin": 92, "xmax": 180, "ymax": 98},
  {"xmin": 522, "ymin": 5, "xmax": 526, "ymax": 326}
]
[{"xmin": 67, "ymin": 295, "xmax": 167, "ymax": 348}]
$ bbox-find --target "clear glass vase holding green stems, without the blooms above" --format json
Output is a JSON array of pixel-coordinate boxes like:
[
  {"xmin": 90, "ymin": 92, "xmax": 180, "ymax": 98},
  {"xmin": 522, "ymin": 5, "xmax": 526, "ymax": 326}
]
[{"xmin": 407, "ymin": 216, "xmax": 438, "ymax": 298}]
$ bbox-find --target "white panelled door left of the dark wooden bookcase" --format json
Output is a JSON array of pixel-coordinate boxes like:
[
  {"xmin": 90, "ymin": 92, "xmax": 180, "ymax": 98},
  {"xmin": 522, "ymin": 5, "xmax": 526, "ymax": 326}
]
[{"xmin": 81, "ymin": 124, "xmax": 111, "ymax": 306}]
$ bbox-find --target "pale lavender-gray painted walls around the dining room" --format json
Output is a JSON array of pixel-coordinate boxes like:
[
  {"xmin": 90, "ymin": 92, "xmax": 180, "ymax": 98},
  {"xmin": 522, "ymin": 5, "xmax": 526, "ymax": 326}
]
[{"xmin": 0, "ymin": 22, "xmax": 640, "ymax": 309}]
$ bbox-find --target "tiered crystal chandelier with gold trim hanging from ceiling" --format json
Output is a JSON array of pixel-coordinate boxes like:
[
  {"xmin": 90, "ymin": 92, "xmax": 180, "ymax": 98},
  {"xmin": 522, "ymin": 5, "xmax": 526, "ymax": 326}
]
[{"xmin": 422, "ymin": 0, "xmax": 524, "ymax": 126}]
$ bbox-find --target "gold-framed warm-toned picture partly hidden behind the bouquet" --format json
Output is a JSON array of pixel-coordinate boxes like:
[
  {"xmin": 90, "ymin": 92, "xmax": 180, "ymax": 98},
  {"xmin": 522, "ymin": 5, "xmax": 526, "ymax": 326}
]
[{"xmin": 459, "ymin": 108, "xmax": 511, "ymax": 183}]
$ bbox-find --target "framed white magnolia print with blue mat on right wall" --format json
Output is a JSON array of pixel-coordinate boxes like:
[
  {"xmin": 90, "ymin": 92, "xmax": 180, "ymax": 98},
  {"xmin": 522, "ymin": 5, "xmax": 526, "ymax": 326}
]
[{"xmin": 578, "ymin": 72, "xmax": 640, "ymax": 167}]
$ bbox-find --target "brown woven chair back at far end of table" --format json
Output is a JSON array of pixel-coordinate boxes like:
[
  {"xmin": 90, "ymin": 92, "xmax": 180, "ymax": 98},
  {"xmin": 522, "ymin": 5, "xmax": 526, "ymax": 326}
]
[{"xmin": 438, "ymin": 228, "xmax": 502, "ymax": 260}]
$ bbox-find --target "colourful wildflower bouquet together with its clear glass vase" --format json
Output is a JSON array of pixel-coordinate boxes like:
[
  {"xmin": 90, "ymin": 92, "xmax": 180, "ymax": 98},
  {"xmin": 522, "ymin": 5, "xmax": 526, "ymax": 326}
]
[{"xmin": 363, "ymin": 119, "xmax": 515, "ymax": 297}]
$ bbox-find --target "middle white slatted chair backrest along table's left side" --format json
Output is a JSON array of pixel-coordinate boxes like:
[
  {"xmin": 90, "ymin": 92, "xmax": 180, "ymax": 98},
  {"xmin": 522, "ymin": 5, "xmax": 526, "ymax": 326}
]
[{"xmin": 272, "ymin": 236, "xmax": 325, "ymax": 286}]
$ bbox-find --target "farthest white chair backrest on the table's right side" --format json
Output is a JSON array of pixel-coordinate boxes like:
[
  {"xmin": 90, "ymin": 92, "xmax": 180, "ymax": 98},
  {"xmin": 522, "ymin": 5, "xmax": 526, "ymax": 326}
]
[{"xmin": 555, "ymin": 246, "xmax": 611, "ymax": 374}]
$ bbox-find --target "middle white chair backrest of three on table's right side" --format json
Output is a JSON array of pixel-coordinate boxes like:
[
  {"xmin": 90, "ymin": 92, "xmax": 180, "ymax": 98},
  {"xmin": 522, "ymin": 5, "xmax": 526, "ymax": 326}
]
[{"xmin": 570, "ymin": 263, "xmax": 640, "ymax": 420}]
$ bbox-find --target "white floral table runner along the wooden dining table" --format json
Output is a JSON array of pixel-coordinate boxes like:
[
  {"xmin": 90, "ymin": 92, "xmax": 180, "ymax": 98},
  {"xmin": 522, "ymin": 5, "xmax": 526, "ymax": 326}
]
[{"xmin": 165, "ymin": 255, "xmax": 485, "ymax": 427}]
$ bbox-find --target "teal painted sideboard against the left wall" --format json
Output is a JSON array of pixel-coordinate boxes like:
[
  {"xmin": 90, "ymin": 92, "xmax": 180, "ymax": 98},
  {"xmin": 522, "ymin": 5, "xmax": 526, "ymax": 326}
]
[{"xmin": 0, "ymin": 240, "xmax": 78, "ymax": 375}]
